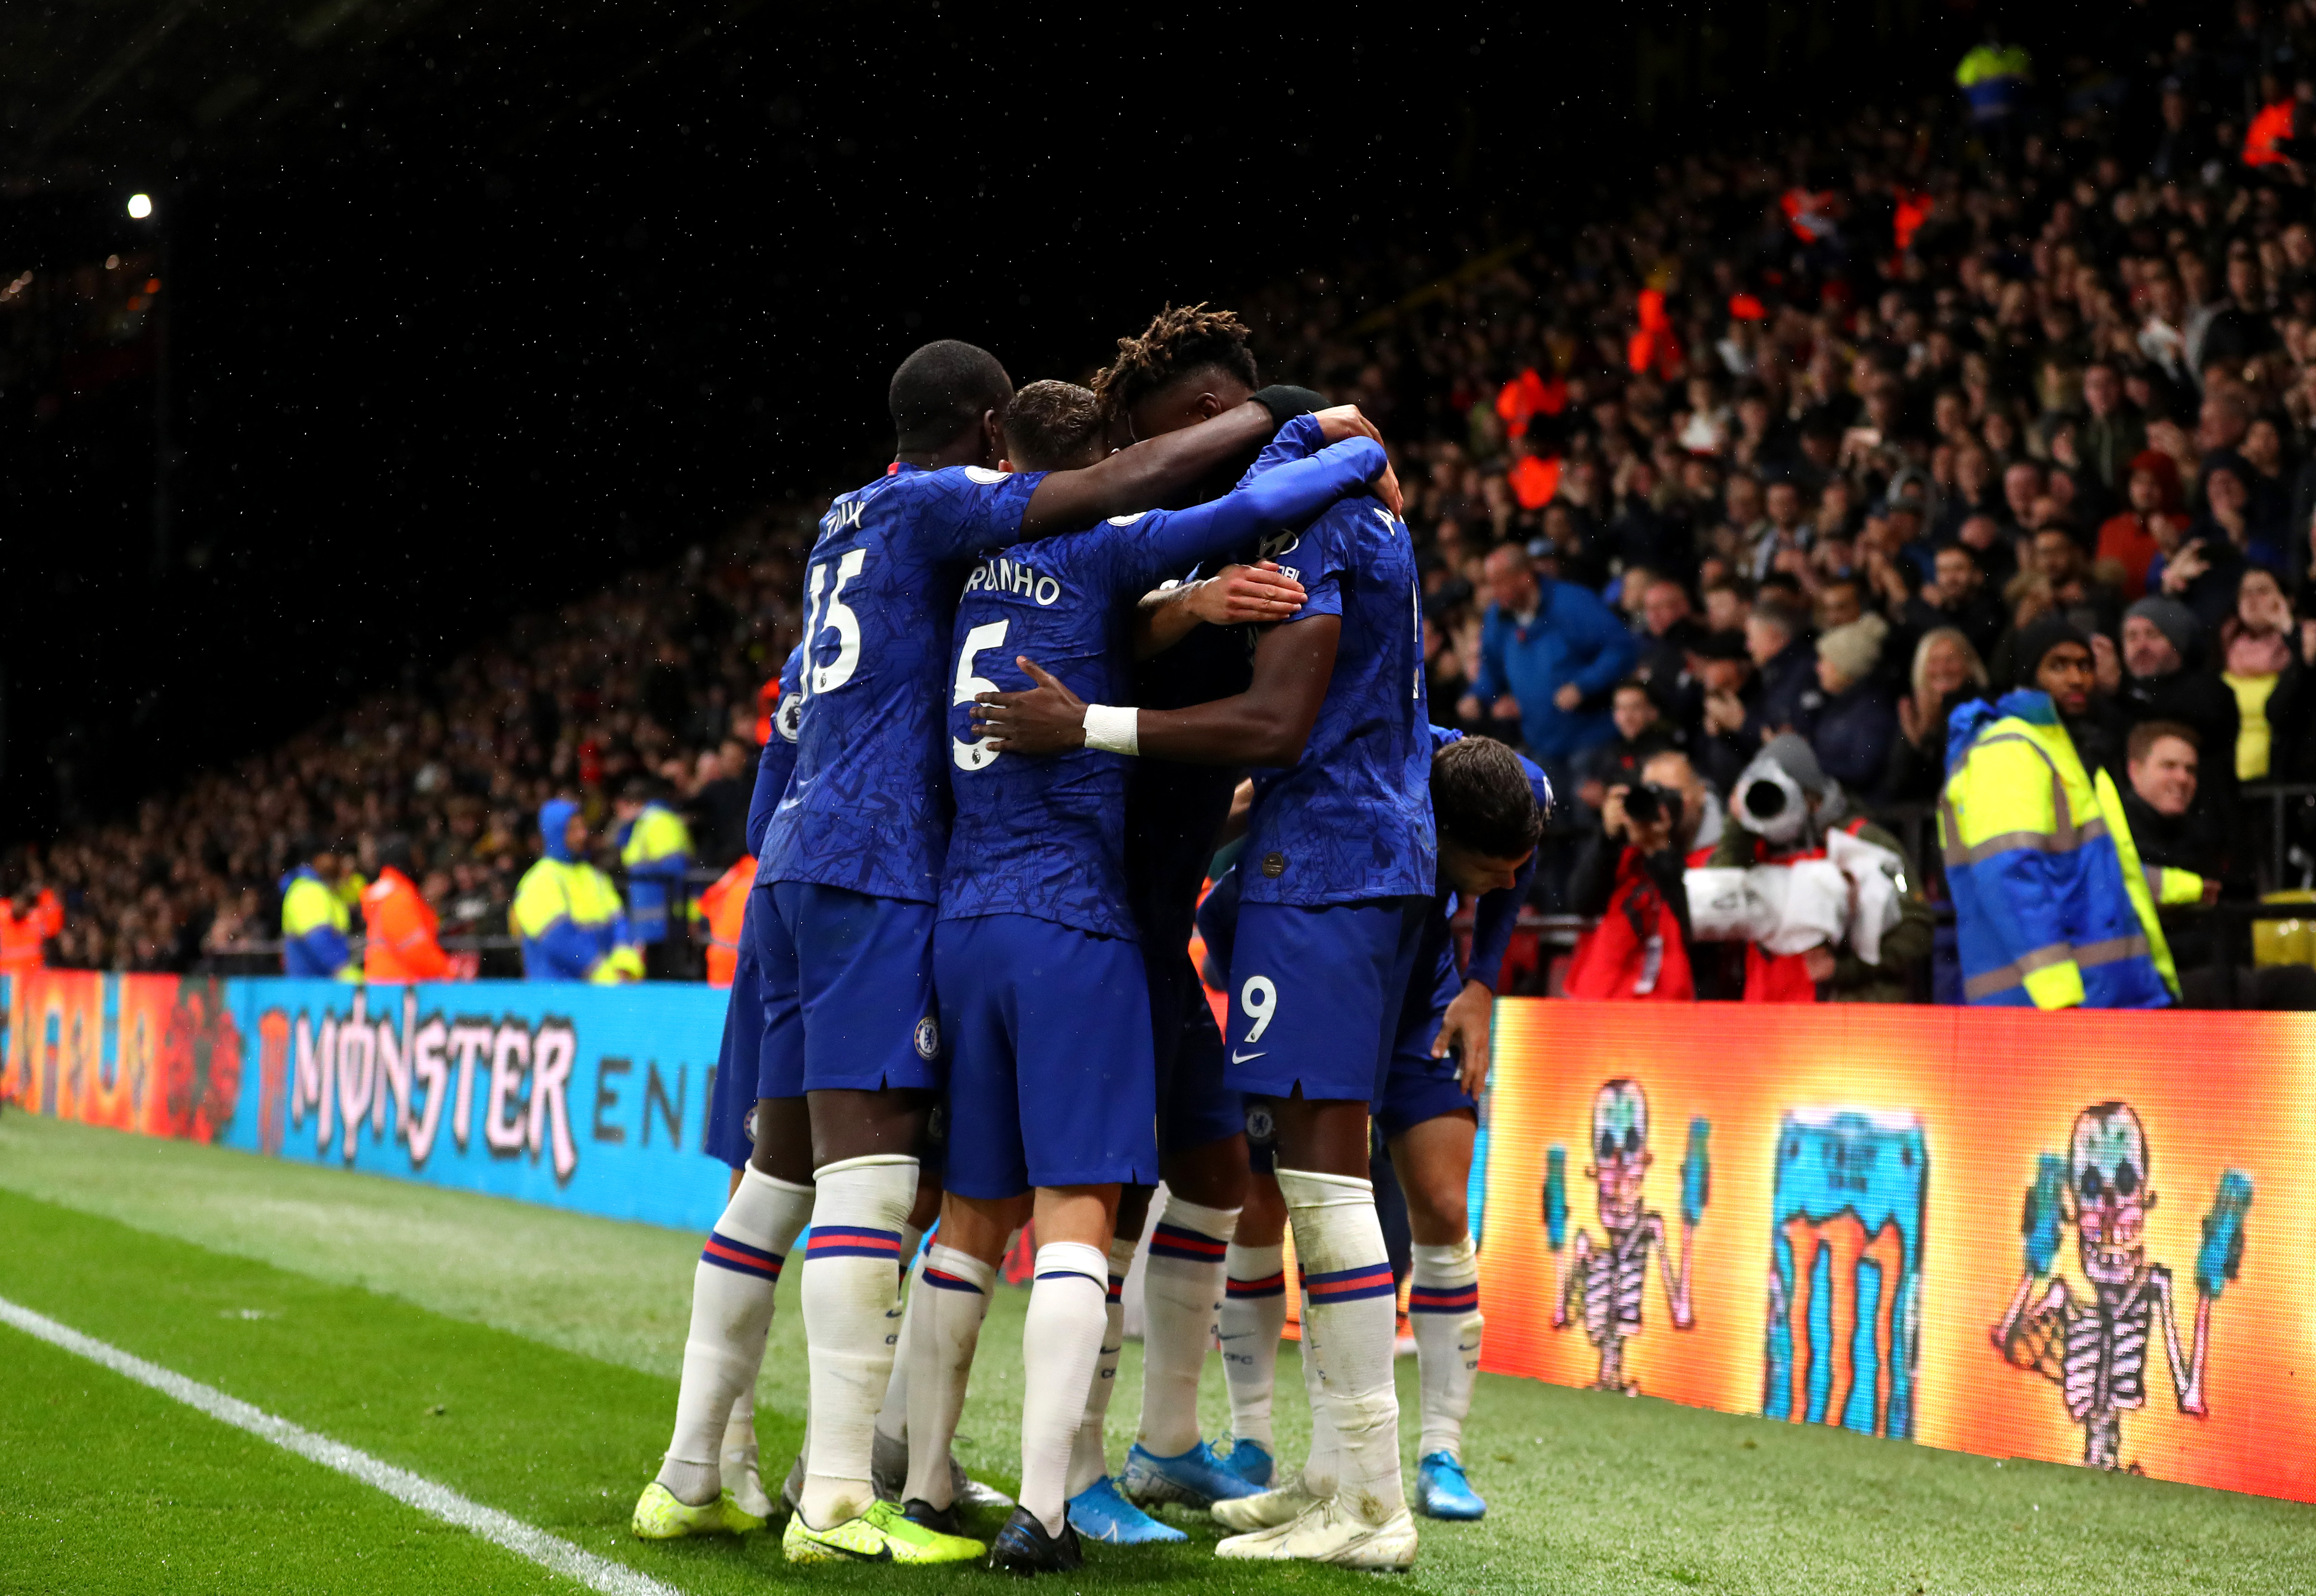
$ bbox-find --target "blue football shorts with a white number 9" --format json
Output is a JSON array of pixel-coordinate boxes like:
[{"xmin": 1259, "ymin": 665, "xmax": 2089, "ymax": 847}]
[{"xmin": 1223, "ymin": 896, "xmax": 1431, "ymax": 1103}]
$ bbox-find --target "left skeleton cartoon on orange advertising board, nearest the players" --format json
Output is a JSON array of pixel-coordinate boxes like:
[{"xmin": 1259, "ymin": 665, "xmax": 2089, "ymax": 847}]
[{"xmin": 1545, "ymin": 1077, "xmax": 1712, "ymax": 1392}]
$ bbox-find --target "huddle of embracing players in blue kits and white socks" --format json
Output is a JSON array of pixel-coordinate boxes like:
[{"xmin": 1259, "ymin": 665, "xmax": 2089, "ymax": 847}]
[{"xmin": 634, "ymin": 308, "xmax": 1550, "ymax": 1573}]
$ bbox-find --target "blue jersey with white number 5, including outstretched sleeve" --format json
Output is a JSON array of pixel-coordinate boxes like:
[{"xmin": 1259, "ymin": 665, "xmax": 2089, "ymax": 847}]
[{"xmin": 940, "ymin": 428, "xmax": 1382, "ymax": 938}]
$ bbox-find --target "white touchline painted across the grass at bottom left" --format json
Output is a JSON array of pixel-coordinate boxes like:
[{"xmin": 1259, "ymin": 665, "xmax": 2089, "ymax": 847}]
[{"xmin": 0, "ymin": 1297, "xmax": 679, "ymax": 1596}]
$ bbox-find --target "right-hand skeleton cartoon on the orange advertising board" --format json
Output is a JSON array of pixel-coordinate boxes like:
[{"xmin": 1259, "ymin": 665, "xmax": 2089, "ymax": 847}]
[{"xmin": 1994, "ymin": 1103, "xmax": 2251, "ymax": 1469}]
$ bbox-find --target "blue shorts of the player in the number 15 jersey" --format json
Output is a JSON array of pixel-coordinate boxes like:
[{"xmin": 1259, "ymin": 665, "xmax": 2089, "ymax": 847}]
[{"xmin": 748, "ymin": 880, "xmax": 945, "ymax": 1098}]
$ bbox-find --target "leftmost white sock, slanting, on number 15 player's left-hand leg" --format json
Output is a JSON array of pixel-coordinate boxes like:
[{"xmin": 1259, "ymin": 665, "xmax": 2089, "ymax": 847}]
[{"xmin": 658, "ymin": 1165, "xmax": 813, "ymax": 1506}]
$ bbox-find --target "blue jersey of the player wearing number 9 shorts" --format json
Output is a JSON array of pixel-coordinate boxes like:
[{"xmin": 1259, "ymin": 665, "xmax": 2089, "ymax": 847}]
[{"xmin": 1239, "ymin": 438, "xmax": 1438, "ymax": 908}]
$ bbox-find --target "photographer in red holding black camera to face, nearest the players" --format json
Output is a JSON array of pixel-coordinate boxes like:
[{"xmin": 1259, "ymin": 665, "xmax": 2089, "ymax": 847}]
[{"xmin": 1563, "ymin": 748, "xmax": 1721, "ymax": 1003}]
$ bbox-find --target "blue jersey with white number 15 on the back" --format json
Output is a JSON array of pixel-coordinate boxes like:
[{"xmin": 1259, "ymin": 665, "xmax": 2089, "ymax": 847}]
[{"xmin": 757, "ymin": 461, "xmax": 1044, "ymax": 903}]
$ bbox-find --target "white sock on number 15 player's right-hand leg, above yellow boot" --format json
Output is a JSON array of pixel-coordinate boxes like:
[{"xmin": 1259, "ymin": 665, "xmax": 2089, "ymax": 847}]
[{"xmin": 799, "ymin": 1154, "xmax": 917, "ymax": 1529}]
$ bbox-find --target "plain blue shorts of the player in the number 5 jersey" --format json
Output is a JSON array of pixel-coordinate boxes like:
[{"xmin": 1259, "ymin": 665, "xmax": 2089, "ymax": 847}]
[{"xmin": 934, "ymin": 915, "xmax": 1158, "ymax": 1200}]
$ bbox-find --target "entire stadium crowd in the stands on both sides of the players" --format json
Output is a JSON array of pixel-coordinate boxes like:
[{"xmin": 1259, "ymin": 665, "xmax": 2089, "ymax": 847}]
[{"xmin": 13, "ymin": 0, "xmax": 2316, "ymax": 998}]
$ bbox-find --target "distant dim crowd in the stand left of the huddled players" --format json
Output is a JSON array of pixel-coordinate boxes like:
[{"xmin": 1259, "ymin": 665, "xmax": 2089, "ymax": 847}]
[{"xmin": 9, "ymin": 532, "xmax": 803, "ymax": 975}]
